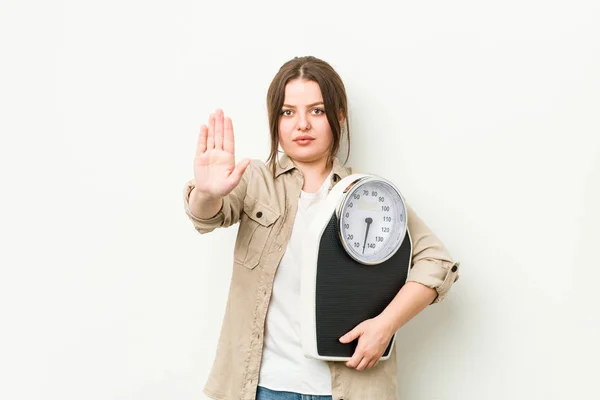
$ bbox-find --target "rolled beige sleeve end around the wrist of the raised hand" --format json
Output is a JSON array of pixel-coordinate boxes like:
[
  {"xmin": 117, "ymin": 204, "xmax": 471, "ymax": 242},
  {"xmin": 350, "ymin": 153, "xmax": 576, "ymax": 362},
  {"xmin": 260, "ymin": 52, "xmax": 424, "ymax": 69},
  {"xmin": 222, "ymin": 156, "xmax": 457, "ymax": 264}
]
[{"xmin": 183, "ymin": 160, "xmax": 255, "ymax": 234}]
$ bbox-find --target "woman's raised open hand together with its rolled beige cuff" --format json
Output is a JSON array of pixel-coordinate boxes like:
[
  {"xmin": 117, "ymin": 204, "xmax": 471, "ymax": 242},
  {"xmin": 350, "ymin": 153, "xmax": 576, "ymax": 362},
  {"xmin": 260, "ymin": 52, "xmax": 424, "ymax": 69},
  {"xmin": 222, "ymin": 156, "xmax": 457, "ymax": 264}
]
[{"xmin": 184, "ymin": 110, "xmax": 252, "ymax": 233}]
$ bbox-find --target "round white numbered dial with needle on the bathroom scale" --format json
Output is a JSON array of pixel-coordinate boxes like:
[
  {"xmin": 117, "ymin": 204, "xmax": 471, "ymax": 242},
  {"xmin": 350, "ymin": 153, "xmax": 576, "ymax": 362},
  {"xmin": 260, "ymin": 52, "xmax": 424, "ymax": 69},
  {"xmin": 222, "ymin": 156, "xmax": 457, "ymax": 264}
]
[{"xmin": 337, "ymin": 176, "xmax": 408, "ymax": 265}]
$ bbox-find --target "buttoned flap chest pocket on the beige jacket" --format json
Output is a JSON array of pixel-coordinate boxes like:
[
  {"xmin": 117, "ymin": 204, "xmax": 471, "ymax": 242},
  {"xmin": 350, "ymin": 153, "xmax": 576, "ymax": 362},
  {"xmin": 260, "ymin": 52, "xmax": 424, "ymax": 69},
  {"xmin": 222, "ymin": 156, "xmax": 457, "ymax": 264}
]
[{"xmin": 233, "ymin": 194, "xmax": 280, "ymax": 269}]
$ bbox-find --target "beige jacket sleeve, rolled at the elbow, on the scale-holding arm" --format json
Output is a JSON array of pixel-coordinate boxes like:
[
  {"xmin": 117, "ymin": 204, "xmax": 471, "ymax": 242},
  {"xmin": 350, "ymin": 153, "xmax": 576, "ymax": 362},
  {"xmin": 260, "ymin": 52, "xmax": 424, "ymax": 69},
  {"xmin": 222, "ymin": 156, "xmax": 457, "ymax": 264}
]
[{"xmin": 407, "ymin": 205, "xmax": 460, "ymax": 304}]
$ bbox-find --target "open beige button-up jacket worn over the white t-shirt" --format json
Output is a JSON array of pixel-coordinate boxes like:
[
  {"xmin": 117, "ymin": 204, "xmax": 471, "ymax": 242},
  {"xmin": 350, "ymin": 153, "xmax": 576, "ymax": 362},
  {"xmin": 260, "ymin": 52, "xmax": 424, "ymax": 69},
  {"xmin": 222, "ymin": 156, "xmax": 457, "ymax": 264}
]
[{"xmin": 184, "ymin": 154, "xmax": 459, "ymax": 400}]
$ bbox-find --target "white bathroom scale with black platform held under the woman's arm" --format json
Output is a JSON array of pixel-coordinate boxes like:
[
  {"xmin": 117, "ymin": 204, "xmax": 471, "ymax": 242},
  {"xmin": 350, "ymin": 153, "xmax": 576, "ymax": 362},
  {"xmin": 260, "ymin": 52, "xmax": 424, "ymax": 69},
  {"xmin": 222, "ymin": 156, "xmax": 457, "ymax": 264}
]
[{"xmin": 301, "ymin": 174, "xmax": 412, "ymax": 361}]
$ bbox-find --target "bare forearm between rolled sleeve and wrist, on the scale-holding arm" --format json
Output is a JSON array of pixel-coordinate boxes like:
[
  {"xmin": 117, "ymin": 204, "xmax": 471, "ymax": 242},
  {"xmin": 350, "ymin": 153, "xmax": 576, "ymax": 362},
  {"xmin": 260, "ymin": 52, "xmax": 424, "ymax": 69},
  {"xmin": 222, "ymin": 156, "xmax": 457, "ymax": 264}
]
[{"xmin": 379, "ymin": 282, "xmax": 437, "ymax": 333}]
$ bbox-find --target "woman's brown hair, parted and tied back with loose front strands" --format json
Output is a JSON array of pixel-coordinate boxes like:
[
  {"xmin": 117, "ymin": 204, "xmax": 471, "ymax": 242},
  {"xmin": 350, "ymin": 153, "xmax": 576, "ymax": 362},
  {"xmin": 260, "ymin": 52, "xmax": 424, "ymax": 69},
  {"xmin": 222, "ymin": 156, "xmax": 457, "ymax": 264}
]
[{"xmin": 267, "ymin": 56, "xmax": 350, "ymax": 177}]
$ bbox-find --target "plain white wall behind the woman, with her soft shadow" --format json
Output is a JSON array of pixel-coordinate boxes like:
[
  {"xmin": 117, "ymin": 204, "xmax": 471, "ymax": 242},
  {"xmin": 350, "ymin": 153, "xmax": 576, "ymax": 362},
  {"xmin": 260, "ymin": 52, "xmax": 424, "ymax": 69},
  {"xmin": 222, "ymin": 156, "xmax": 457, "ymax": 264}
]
[{"xmin": 0, "ymin": 0, "xmax": 600, "ymax": 400}]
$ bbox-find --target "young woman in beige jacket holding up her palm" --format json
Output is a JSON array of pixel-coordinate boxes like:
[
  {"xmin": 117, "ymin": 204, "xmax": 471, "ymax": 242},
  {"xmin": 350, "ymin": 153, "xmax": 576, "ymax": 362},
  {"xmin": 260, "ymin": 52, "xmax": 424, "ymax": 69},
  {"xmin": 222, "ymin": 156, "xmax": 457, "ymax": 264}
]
[{"xmin": 184, "ymin": 57, "xmax": 459, "ymax": 400}]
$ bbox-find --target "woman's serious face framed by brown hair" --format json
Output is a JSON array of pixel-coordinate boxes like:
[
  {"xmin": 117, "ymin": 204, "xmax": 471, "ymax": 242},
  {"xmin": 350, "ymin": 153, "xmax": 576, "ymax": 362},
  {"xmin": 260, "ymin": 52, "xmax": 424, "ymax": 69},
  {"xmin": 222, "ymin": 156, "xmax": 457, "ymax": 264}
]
[{"xmin": 279, "ymin": 79, "xmax": 333, "ymax": 163}]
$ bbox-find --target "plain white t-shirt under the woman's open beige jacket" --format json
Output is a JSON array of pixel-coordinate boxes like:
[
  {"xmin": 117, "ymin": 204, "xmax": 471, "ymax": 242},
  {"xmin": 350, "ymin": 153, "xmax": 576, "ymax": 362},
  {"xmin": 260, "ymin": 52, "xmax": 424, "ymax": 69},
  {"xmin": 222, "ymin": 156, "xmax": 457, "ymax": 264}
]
[{"xmin": 258, "ymin": 171, "xmax": 333, "ymax": 395}]
